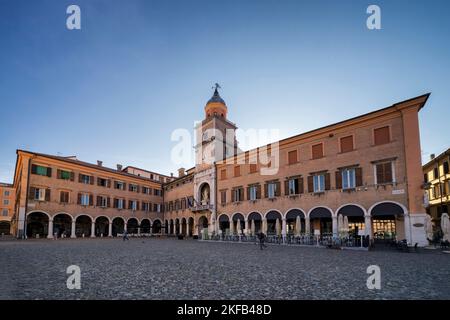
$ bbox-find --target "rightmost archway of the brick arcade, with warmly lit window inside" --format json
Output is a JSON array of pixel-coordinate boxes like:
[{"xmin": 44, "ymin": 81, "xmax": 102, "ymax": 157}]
[{"xmin": 370, "ymin": 202, "xmax": 405, "ymax": 242}]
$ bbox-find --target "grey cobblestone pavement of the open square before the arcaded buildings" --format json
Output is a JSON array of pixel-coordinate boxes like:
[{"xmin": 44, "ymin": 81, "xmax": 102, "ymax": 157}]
[{"xmin": 0, "ymin": 238, "xmax": 450, "ymax": 299}]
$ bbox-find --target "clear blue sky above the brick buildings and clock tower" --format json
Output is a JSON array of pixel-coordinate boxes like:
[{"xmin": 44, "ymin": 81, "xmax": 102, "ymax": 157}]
[{"xmin": 0, "ymin": 0, "xmax": 450, "ymax": 182}]
